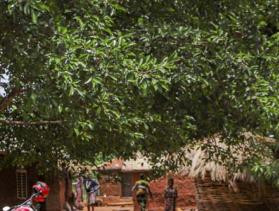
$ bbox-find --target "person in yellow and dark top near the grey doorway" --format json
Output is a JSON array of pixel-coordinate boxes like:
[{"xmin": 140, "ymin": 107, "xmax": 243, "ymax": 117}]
[{"xmin": 132, "ymin": 174, "xmax": 152, "ymax": 211}]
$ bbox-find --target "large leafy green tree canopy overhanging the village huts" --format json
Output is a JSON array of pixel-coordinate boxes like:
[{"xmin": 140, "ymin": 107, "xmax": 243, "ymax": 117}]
[{"xmin": 0, "ymin": 0, "xmax": 279, "ymax": 180}]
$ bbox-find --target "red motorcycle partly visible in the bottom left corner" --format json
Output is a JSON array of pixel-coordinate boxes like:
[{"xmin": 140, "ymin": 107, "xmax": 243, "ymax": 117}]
[{"xmin": 2, "ymin": 182, "xmax": 49, "ymax": 211}]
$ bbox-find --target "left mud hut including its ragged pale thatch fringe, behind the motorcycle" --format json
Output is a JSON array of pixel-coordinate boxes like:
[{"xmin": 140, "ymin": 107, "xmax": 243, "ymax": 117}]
[{"xmin": 0, "ymin": 153, "xmax": 93, "ymax": 211}]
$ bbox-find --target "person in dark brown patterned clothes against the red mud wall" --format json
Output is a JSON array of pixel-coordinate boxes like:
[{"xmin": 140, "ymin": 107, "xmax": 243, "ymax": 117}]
[{"xmin": 164, "ymin": 177, "xmax": 177, "ymax": 211}]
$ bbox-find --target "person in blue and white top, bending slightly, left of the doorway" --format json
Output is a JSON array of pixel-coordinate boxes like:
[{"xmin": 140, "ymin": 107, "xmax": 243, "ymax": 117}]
[{"xmin": 84, "ymin": 177, "xmax": 100, "ymax": 211}]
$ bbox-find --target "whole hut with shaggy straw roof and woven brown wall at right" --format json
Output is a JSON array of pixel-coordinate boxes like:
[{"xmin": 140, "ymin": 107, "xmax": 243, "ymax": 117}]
[{"xmin": 179, "ymin": 133, "xmax": 279, "ymax": 211}]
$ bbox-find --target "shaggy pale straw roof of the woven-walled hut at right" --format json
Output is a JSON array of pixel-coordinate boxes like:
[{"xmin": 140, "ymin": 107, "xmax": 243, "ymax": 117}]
[{"xmin": 180, "ymin": 133, "xmax": 275, "ymax": 185}]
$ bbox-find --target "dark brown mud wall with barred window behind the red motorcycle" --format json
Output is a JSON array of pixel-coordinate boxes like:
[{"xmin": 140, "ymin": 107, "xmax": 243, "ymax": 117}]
[{"xmin": 0, "ymin": 152, "xmax": 70, "ymax": 211}]
